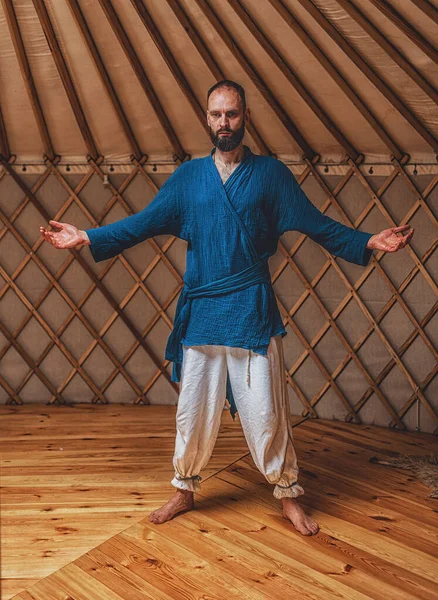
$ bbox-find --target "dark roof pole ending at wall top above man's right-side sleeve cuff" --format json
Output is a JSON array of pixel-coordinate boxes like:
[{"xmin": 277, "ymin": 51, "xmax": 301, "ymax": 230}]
[{"xmin": 228, "ymin": 0, "xmax": 359, "ymax": 160}]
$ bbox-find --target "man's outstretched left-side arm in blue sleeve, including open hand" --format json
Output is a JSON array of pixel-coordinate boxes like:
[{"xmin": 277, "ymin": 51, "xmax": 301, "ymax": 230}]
[{"xmin": 40, "ymin": 167, "xmax": 184, "ymax": 262}]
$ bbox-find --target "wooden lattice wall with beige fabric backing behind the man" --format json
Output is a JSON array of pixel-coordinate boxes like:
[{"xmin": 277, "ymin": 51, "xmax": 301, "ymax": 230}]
[{"xmin": 0, "ymin": 159, "xmax": 438, "ymax": 432}]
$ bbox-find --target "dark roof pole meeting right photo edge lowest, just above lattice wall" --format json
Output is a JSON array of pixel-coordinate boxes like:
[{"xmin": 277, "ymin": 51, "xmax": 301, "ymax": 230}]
[{"xmin": 298, "ymin": 0, "xmax": 438, "ymax": 152}]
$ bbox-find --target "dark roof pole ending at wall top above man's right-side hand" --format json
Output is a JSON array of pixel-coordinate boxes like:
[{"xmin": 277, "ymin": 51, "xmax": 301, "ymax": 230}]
[{"xmin": 269, "ymin": 0, "xmax": 403, "ymax": 160}]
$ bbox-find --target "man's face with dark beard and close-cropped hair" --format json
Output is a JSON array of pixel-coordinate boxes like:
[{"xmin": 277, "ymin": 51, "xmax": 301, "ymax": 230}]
[{"xmin": 207, "ymin": 87, "xmax": 249, "ymax": 152}]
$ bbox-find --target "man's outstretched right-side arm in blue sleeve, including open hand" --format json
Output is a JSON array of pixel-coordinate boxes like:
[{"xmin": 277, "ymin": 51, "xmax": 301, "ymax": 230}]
[{"xmin": 273, "ymin": 165, "xmax": 414, "ymax": 266}]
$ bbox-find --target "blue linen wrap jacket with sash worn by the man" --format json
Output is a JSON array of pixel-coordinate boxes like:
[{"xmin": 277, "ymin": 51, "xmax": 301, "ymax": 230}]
[{"xmin": 86, "ymin": 146, "xmax": 372, "ymax": 418}]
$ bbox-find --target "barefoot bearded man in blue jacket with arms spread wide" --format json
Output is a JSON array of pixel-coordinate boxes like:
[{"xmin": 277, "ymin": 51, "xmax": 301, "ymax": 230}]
[{"xmin": 40, "ymin": 80, "xmax": 413, "ymax": 535}]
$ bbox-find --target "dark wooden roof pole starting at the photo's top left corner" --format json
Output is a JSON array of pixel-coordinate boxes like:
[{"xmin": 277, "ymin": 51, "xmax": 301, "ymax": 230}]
[{"xmin": 2, "ymin": 0, "xmax": 55, "ymax": 160}]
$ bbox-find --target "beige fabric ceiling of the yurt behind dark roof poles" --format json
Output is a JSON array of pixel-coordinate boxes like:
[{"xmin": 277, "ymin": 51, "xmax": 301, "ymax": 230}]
[{"xmin": 0, "ymin": 0, "xmax": 438, "ymax": 164}]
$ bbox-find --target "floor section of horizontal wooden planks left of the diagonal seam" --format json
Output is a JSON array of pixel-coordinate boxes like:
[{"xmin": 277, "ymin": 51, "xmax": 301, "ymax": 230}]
[{"xmin": 0, "ymin": 405, "xmax": 247, "ymax": 600}]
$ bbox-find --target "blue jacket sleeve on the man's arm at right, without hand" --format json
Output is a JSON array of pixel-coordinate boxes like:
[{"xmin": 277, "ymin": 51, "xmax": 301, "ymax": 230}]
[{"xmin": 271, "ymin": 161, "xmax": 373, "ymax": 266}]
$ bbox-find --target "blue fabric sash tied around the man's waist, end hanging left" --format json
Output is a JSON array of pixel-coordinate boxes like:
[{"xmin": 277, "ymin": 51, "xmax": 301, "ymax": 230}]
[{"xmin": 166, "ymin": 260, "xmax": 271, "ymax": 381}]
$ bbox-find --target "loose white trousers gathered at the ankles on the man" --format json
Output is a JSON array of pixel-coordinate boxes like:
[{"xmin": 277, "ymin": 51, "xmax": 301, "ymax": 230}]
[{"xmin": 172, "ymin": 335, "xmax": 304, "ymax": 499}]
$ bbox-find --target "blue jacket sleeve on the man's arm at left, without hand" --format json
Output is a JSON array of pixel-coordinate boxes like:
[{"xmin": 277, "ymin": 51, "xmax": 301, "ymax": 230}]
[{"xmin": 85, "ymin": 165, "xmax": 184, "ymax": 262}]
